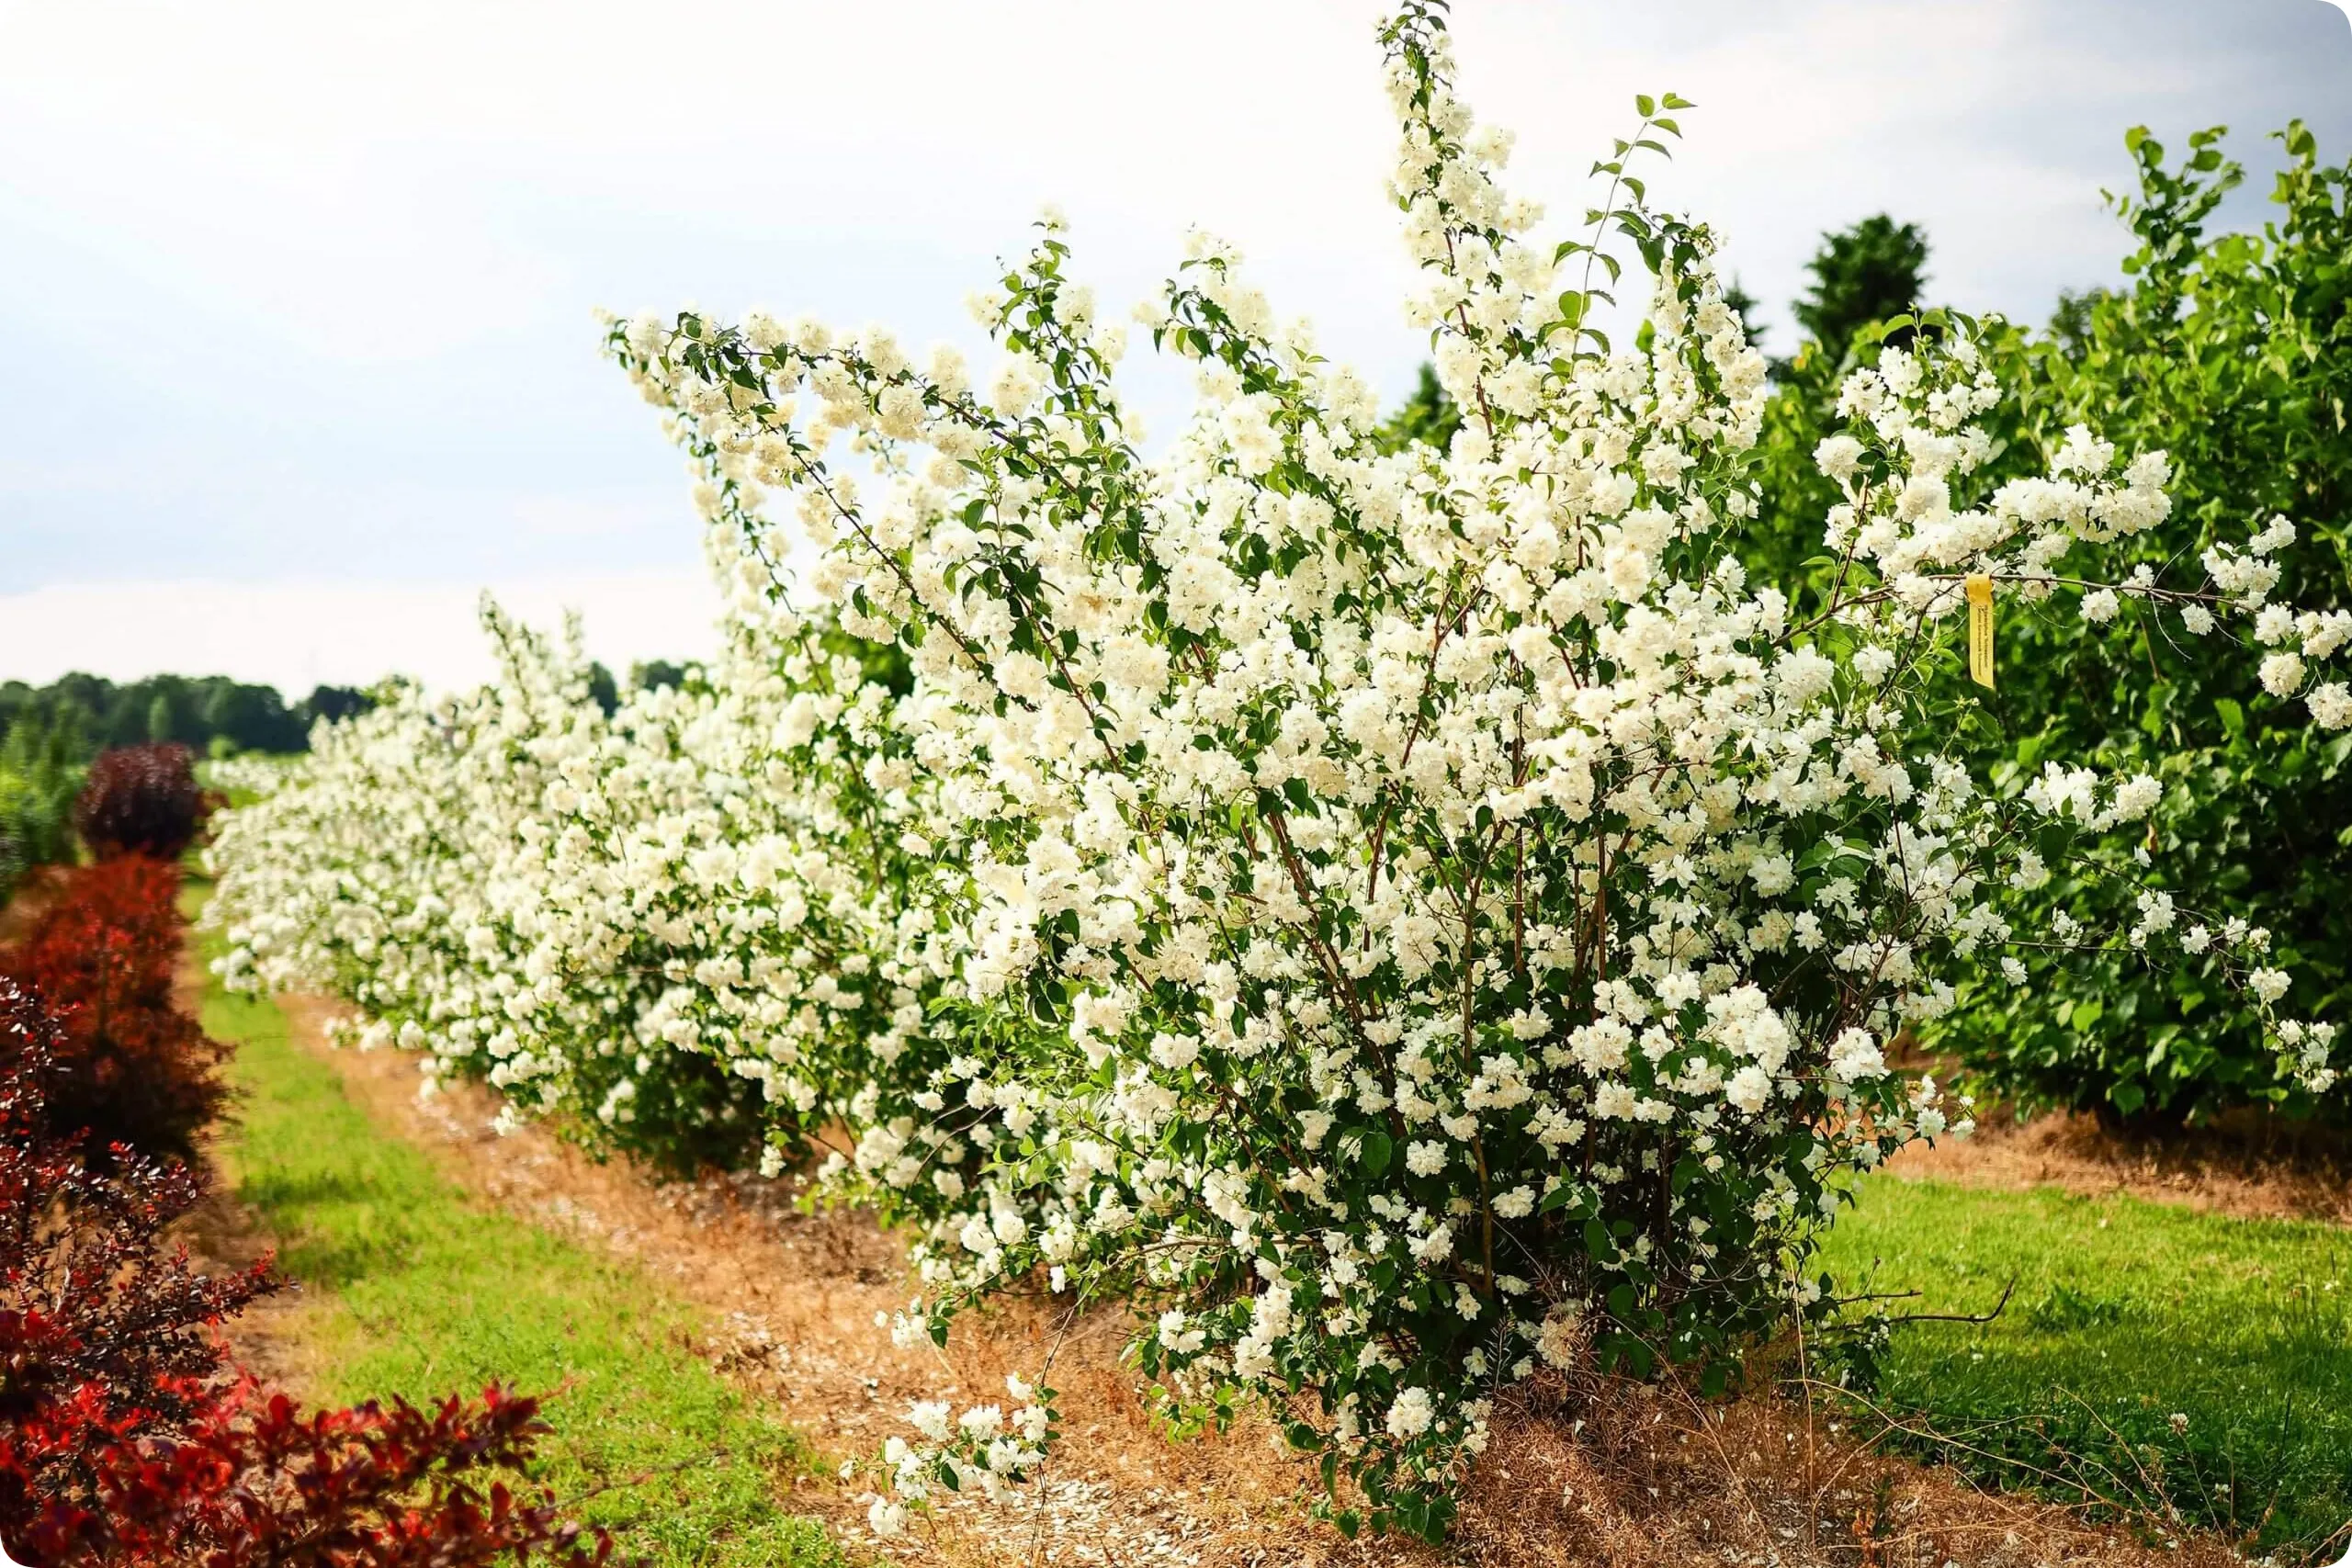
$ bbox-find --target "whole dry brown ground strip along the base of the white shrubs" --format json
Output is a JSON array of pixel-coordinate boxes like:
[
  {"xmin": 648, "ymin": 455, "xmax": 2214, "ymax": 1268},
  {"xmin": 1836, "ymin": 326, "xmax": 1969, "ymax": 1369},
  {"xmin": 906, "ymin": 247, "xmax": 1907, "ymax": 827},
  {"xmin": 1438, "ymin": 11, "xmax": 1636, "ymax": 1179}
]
[{"xmin": 257, "ymin": 997, "xmax": 2239, "ymax": 1568}]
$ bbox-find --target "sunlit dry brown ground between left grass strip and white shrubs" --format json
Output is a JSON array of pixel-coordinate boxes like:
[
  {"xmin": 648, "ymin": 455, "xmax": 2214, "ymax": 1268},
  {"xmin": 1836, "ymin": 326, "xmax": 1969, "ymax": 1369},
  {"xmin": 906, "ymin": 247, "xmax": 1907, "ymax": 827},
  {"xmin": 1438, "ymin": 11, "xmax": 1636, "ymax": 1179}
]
[{"xmin": 269, "ymin": 997, "xmax": 1383, "ymax": 1565}]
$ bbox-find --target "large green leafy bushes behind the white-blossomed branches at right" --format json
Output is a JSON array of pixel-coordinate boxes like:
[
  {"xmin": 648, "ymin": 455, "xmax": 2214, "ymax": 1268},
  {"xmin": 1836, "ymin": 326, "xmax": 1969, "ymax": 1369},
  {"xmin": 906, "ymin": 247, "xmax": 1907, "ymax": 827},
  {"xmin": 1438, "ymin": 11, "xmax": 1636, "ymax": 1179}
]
[{"xmin": 1746, "ymin": 122, "xmax": 2352, "ymax": 1126}]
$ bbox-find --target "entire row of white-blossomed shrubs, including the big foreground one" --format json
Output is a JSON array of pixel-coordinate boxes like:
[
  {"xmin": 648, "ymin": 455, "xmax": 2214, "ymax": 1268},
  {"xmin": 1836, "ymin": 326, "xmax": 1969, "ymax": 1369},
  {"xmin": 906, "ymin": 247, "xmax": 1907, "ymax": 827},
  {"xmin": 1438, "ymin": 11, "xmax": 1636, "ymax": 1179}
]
[{"xmin": 214, "ymin": 3, "xmax": 2352, "ymax": 1533}]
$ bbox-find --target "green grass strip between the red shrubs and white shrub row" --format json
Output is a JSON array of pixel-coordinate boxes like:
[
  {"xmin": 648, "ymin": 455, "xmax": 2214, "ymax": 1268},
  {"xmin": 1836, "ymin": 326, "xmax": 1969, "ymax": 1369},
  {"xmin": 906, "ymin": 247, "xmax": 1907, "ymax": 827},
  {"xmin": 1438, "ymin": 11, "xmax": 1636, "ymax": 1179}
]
[{"xmin": 190, "ymin": 888, "xmax": 840, "ymax": 1568}]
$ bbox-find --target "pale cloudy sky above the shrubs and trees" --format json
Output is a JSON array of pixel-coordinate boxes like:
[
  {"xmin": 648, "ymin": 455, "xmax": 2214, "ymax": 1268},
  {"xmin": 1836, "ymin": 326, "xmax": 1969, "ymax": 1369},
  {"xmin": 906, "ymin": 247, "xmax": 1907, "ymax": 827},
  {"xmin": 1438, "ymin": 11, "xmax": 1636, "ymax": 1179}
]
[{"xmin": 0, "ymin": 0, "xmax": 2352, "ymax": 689}]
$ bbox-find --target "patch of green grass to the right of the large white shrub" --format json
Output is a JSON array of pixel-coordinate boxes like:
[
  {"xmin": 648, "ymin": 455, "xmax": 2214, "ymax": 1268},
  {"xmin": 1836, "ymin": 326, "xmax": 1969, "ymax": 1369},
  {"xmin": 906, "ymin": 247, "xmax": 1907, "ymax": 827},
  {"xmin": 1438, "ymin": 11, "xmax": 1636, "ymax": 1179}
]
[{"xmin": 1826, "ymin": 1176, "xmax": 2352, "ymax": 1547}]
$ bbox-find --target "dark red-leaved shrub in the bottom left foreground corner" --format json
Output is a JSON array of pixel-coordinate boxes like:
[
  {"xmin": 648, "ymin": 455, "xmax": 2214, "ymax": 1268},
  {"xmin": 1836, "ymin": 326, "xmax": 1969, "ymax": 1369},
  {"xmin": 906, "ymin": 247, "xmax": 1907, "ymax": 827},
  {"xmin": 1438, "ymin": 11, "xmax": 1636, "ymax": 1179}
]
[{"xmin": 0, "ymin": 980, "xmax": 612, "ymax": 1568}]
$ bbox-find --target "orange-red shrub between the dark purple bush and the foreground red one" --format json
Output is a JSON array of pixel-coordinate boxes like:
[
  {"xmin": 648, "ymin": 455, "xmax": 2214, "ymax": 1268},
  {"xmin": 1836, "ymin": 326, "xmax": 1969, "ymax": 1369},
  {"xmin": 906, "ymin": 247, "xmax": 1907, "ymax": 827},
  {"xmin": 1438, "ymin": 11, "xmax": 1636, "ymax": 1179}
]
[{"xmin": 0, "ymin": 856, "xmax": 228, "ymax": 1161}]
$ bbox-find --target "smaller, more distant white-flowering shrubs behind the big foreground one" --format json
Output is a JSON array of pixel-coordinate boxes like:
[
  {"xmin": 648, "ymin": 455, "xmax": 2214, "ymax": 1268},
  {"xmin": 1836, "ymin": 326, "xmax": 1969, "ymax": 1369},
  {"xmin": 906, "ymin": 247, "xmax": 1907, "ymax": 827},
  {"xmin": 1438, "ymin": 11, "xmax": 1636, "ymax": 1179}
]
[{"xmin": 211, "ymin": 594, "xmax": 981, "ymax": 1185}]
